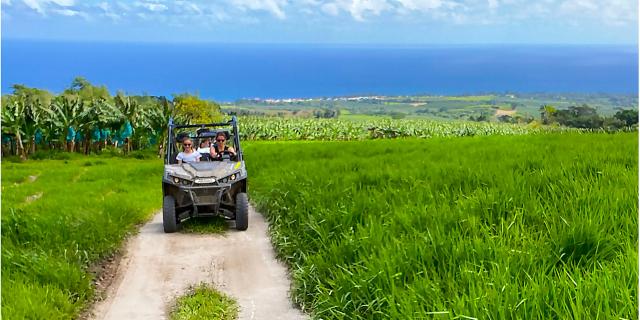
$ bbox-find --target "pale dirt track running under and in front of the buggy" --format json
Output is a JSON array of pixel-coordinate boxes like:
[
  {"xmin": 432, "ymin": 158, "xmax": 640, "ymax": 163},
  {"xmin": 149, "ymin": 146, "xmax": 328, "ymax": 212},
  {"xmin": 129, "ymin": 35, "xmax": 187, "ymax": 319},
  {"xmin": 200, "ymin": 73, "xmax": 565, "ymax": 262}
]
[{"xmin": 92, "ymin": 208, "xmax": 307, "ymax": 320}]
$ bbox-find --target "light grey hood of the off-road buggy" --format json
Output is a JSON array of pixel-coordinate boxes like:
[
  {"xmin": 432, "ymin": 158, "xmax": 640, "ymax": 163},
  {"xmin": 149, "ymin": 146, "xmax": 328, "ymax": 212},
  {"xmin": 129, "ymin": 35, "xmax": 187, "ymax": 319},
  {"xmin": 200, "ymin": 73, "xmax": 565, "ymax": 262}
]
[{"xmin": 165, "ymin": 161, "xmax": 242, "ymax": 180}]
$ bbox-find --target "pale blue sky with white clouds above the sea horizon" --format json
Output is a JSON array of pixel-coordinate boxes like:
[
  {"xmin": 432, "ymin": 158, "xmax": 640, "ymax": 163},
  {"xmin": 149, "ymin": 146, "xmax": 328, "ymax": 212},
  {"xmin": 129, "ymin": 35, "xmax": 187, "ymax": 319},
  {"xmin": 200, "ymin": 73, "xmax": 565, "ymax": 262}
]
[{"xmin": 1, "ymin": 0, "xmax": 638, "ymax": 45}]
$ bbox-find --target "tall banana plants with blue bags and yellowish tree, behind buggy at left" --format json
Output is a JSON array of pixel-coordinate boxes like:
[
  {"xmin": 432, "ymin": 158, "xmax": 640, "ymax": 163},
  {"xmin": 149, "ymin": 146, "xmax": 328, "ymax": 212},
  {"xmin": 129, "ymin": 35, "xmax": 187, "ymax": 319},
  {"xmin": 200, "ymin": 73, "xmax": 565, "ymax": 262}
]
[{"xmin": 1, "ymin": 78, "xmax": 221, "ymax": 159}]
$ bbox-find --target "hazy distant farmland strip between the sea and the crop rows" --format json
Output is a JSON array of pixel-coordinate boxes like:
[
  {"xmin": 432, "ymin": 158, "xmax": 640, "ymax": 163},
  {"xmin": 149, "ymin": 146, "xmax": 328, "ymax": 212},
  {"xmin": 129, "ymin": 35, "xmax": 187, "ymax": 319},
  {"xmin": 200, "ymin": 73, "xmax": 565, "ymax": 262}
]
[{"xmin": 229, "ymin": 93, "xmax": 638, "ymax": 121}]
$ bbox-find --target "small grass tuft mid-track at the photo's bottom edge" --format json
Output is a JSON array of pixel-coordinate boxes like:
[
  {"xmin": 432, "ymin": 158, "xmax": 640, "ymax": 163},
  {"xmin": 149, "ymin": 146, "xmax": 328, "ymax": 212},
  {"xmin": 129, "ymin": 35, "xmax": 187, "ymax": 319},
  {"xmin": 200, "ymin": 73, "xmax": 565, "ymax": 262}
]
[{"xmin": 170, "ymin": 284, "xmax": 238, "ymax": 320}]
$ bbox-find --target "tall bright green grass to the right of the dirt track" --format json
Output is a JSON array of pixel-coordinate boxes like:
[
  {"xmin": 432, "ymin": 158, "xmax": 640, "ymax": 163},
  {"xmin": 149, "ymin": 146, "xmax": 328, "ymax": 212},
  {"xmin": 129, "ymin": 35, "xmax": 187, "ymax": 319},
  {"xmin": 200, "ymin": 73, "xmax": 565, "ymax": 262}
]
[{"xmin": 245, "ymin": 134, "xmax": 638, "ymax": 319}]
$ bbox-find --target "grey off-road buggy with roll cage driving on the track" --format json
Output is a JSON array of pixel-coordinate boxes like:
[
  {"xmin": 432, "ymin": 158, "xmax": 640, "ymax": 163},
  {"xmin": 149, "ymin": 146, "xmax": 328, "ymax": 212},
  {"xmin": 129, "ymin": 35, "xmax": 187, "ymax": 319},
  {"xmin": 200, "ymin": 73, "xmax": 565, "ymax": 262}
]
[{"xmin": 162, "ymin": 116, "xmax": 249, "ymax": 233}]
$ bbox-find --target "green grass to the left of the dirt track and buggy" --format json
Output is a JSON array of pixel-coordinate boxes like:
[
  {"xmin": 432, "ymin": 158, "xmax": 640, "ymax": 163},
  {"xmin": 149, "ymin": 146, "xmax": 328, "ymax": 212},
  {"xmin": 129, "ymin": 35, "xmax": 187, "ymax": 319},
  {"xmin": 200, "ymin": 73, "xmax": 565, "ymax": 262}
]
[{"xmin": 2, "ymin": 155, "xmax": 162, "ymax": 319}]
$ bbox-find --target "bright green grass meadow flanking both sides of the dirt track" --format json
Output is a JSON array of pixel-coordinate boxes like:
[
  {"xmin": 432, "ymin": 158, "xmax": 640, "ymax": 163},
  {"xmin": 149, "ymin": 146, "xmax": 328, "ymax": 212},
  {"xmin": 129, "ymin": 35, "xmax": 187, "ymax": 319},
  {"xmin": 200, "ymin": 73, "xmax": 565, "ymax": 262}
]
[{"xmin": 2, "ymin": 129, "xmax": 638, "ymax": 319}]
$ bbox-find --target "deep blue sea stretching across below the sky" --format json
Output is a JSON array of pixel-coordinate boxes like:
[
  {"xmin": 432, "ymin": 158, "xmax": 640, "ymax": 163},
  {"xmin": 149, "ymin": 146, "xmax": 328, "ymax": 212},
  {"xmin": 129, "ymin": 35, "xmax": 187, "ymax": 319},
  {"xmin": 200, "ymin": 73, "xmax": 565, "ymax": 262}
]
[{"xmin": 1, "ymin": 39, "xmax": 638, "ymax": 101}]
